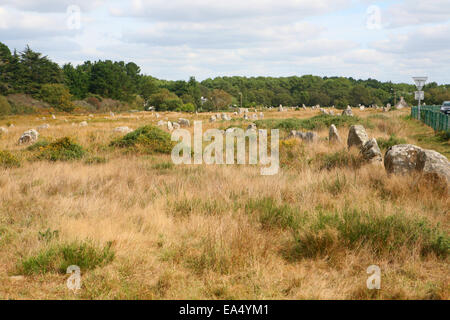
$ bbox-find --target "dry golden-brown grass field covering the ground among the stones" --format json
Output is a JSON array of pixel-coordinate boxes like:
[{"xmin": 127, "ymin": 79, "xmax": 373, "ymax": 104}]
[{"xmin": 0, "ymin": 110, "xmax": 450, "ymax": 299}]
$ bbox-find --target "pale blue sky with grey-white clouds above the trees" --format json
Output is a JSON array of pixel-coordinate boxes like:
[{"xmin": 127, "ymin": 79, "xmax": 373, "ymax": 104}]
[{"xmin": 0, "ymin": 0, "xmax": 450, "ymax": 84}]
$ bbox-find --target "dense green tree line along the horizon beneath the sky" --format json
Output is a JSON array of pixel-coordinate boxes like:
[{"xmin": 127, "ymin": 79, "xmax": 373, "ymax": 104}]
[{"xmin": 0, "ymin": 42, "xmax": 450, "ymax": 112}]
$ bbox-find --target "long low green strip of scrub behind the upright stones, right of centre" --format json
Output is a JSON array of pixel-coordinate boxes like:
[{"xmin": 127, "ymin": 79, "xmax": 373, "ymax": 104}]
[{"xmin": 255, "ymin": 114, "xmax": 373, "ymax": 131}]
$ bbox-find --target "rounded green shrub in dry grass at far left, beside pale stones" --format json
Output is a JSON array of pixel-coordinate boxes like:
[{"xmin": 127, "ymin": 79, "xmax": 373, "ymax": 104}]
[{"xmin": 37, "ymin": 137, "xmax": 86, "ymax": 161}]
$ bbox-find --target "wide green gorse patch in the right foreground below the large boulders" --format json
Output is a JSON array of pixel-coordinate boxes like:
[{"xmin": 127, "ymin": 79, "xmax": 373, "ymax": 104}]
[{"xmin": 294, "ymin": 209, "xmax": 450, "ymax": 258}]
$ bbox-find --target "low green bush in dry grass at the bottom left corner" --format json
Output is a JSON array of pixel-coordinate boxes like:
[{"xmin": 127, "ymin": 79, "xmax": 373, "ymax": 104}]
[{"xmin": 17, "ymin": 242, "xmax": 114, "ymax": 275}]
